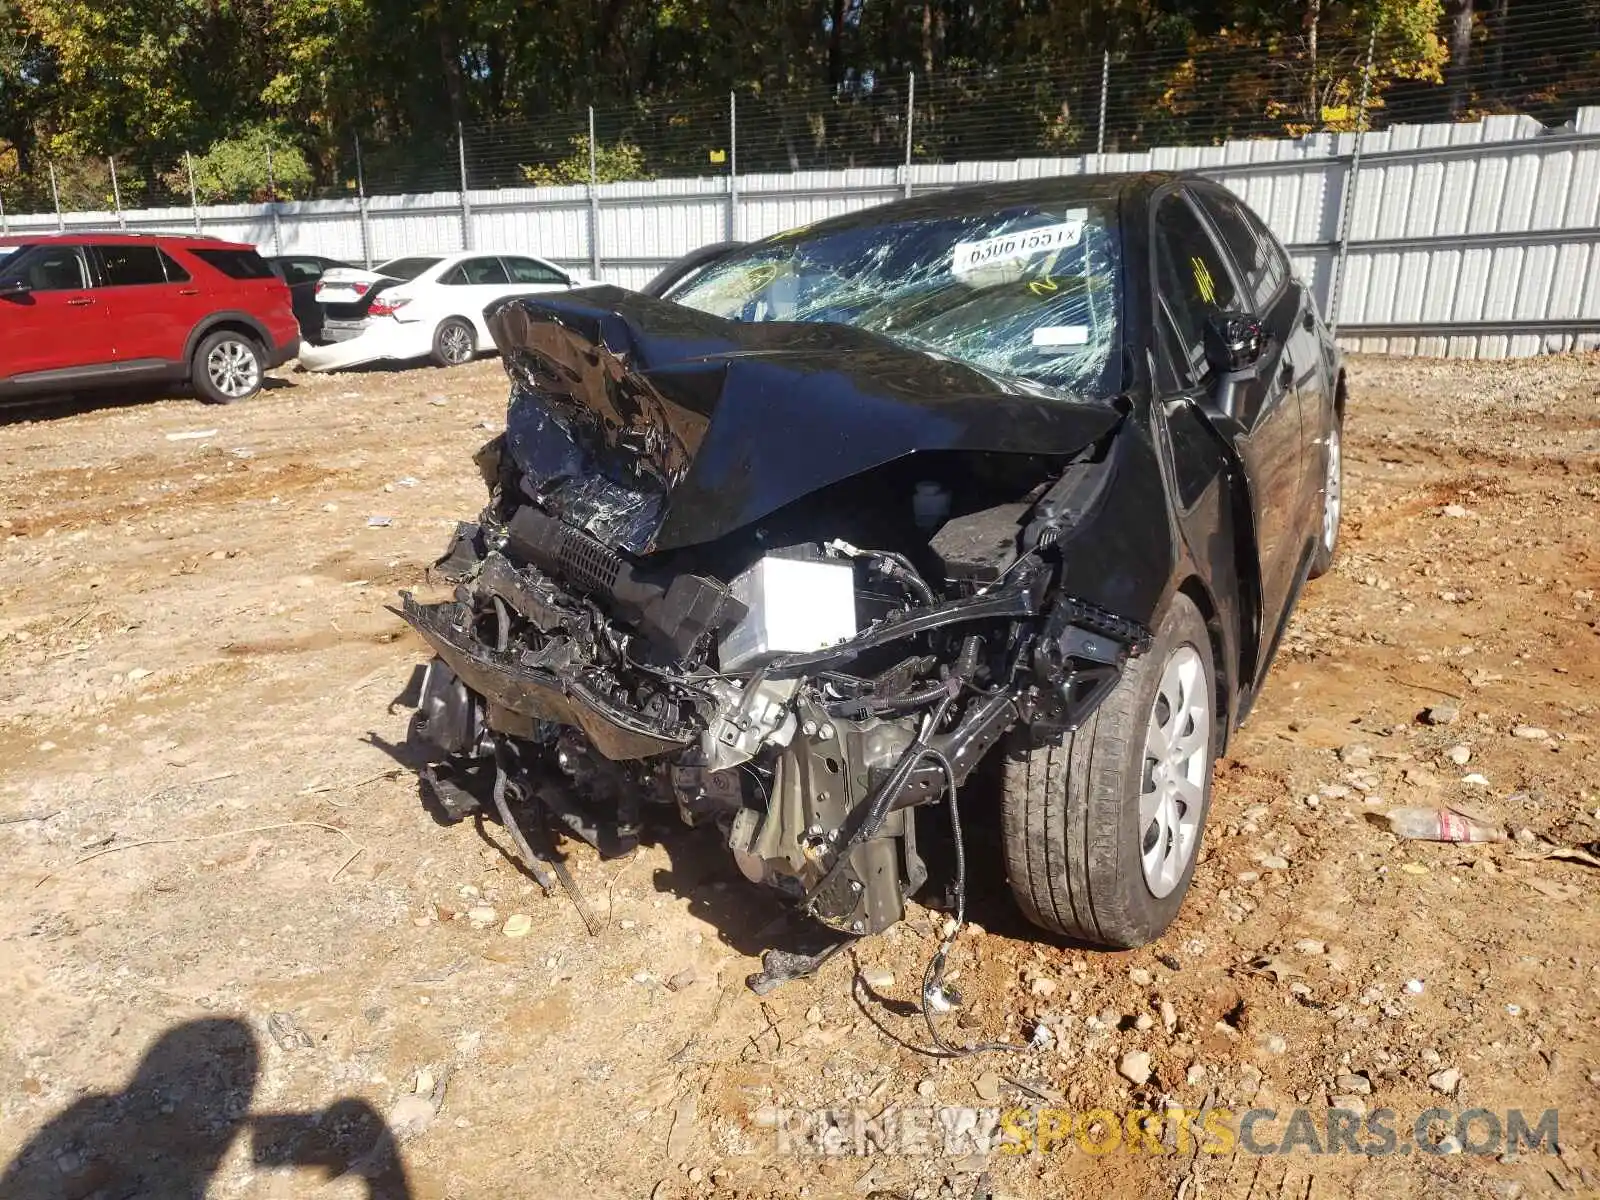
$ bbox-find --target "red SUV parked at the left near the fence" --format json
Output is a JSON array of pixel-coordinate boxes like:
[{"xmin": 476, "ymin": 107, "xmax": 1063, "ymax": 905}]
[{"xmin": 0, "ymin": 232, "xmax": 299, "ymax": 405}]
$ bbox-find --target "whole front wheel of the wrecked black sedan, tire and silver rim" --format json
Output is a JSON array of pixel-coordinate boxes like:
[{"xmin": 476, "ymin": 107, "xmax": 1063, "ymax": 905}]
[{"xmin": 1002, "ymin": 594, "xmax": 1218, "ymax": 947}]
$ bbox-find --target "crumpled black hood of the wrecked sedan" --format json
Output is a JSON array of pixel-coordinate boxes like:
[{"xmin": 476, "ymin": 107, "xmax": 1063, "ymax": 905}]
[{"xmin": 486, "ymin": 286, "xmax": 1125, "ymax": 554}]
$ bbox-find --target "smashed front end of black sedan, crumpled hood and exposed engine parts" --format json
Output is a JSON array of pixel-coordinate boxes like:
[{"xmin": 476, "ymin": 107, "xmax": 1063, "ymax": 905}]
[{"xmin": 403, "ymin": 290, "xmax": 1149, "ymax": 934}]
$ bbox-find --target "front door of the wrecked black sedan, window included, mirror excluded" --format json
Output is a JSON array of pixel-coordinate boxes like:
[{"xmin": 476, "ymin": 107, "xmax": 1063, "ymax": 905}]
[{"xmin": 1152, "ymin": 189, "xmax": 1302, "ymax": 667}]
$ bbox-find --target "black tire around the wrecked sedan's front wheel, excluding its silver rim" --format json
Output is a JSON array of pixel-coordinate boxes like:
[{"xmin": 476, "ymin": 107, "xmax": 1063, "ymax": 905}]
[{"xmin": 1002, "ymin": 594, "xmax": 1218, "ymax": 947}]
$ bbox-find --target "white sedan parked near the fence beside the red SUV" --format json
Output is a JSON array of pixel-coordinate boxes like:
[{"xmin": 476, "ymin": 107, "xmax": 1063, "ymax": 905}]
[{"xmin": 299, "ymin": 250, "xmax": 590, "ymax": 371}]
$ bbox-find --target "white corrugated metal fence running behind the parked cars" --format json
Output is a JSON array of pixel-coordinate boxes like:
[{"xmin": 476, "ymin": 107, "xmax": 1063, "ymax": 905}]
[{"xmin": 8, "ymin": 107, "xmax": 1600, "ymax": 357}]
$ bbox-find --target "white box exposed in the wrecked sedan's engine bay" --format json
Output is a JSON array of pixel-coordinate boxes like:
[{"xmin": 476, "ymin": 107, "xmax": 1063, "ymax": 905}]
[{"xmin": 717, "ymin": 555, "xmax": 856, "ymax": 670}]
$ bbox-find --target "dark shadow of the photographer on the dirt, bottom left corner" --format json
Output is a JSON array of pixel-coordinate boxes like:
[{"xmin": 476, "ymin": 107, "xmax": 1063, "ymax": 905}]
[{"xmin": 0, "ymin": 1018, "xmax": 411, "ymax": 1200}]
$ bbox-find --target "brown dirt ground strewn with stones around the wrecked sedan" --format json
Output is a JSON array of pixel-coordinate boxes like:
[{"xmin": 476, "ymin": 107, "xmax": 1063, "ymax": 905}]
[{"xmin": 0, "ymin": 350, "xmax": 1600, "ymax": 1200}]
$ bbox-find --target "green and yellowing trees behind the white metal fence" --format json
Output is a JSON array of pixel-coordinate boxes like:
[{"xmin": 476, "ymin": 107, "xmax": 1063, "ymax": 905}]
[{"xmin": 0, "ymin": 0, "xmax": 1600, "ymax": 203}]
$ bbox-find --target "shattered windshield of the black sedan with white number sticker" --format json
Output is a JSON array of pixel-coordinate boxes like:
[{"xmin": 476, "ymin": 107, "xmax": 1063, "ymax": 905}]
[{"xmin": 672, "ymin": 202, "xmax": 1122, "ymax": 395}]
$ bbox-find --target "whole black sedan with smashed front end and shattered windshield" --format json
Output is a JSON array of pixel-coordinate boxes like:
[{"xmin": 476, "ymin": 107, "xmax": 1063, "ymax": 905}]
[{"xmin": 396, "ymin": 174, "xmax": 1346, "ymax": 979}]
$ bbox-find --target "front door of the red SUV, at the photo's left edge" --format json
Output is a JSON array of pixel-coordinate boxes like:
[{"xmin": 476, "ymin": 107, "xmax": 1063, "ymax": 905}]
[{"xmin": 0, "ymin": 245, "xmax": 112, "ymax": 379}]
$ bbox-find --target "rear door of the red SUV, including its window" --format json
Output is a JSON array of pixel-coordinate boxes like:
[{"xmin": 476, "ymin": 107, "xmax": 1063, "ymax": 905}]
[{"xmin": 90, "ymin": 242, "xmax": 188, "ymax": 363}]
